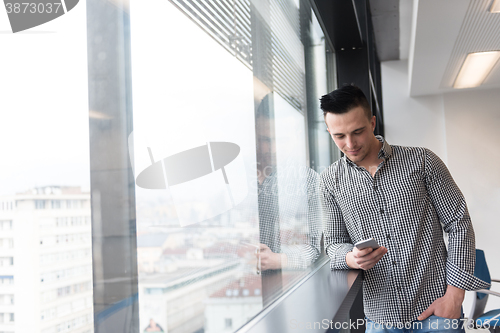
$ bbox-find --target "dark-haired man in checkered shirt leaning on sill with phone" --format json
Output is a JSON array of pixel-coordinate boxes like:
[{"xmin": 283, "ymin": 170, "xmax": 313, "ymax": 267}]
[{"xmin": 321, "ymin": 85, "xmax": 488, "ymax": 331}]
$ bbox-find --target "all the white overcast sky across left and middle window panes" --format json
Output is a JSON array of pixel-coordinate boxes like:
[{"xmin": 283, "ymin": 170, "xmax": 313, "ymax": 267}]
[{"xmin": 0, "ymin": 0, "xmax": 306, "ymax": 194}]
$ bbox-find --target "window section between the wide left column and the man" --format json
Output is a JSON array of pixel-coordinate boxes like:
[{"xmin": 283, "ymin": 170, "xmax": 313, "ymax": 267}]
[{"xmin": 128, "ymin": 0, "xmax": 330, "ymax": 333}]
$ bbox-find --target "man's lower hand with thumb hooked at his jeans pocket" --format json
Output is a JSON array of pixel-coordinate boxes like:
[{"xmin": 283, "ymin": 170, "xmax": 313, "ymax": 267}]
[{"xmin": 417, "ymin": 285, "xmax": 465, "ymax": 321}]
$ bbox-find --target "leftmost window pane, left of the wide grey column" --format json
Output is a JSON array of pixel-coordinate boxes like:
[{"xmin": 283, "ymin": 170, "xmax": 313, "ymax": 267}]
[{"xmin": 0, "ymin": 1, "xmax": 93, "ymax": 333}]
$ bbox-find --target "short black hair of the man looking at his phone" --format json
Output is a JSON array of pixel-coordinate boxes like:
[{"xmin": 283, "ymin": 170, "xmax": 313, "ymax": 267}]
[{"xmin": 320, "ymin": 84, "xmax": 372, "ymax": 119}]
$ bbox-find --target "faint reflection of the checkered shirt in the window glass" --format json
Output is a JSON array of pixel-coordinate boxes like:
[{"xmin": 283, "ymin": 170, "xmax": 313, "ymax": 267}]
[{"xmin": 258, "ymin": 165, "xmax": 323, "ymax": 269}]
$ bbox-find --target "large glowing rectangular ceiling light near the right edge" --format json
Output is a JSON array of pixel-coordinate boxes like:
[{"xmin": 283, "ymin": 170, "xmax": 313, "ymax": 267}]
[{"xmin": 453, "ymin": 51, "xmax": 500, "ymax": 89}]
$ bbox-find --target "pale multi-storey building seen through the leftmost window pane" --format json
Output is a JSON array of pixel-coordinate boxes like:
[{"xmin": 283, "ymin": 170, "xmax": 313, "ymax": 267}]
[{"xmin": 0, "ymin": 186, "xmax": 93, "ymax": 333}]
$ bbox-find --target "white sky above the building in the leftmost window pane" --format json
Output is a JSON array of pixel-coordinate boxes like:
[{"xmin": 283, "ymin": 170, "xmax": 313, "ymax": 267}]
[{"xmin": 0, "ymin": 1, "xmax": 90, "ymax": 194}]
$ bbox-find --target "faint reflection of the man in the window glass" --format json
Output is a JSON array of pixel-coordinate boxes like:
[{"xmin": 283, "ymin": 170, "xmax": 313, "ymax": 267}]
[{"xmin": 255, "ymin": 94, "xmax": 322, "ymax": 276}]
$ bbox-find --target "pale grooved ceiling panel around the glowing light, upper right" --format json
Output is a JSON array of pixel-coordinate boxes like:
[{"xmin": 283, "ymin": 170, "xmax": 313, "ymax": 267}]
[{"xmin": 408, "ymin": 0, "xmax": 500, "ymax": 96}]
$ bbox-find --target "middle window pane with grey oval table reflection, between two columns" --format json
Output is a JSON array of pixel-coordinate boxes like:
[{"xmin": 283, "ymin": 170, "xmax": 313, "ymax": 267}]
[{"xmin": 129, "ymin": 1, "xmax": 262, "ymax": 332}]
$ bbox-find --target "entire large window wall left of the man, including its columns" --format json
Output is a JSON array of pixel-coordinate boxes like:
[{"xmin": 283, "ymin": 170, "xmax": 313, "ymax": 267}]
[{"xmin": 0, "ymin": 0, "xmax": 336, "ymax": 333}]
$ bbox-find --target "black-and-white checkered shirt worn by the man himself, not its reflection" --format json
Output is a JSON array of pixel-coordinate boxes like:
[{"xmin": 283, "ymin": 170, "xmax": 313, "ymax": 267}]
[{"xmin": 321, "ymin": 136, "xmax": 489, "ymax": 324}]
